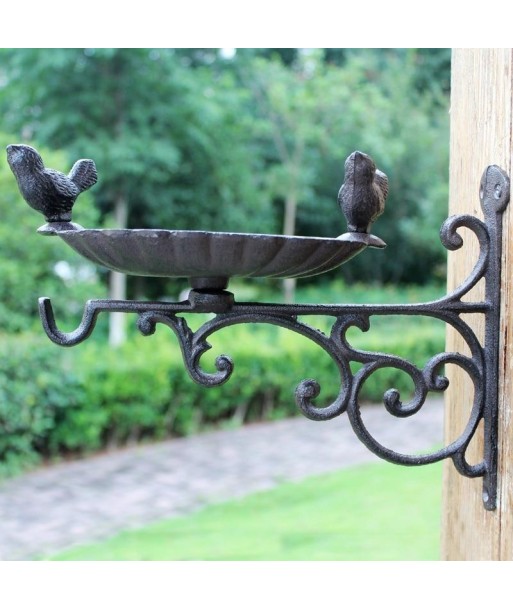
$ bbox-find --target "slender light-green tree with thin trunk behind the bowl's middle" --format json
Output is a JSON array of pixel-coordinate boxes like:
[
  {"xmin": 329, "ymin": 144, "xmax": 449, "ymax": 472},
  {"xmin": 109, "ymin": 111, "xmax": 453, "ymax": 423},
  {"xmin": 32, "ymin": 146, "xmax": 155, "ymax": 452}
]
[{"xmin": 243, "ymin": 50, "xmax": 348, "ymax": 301}]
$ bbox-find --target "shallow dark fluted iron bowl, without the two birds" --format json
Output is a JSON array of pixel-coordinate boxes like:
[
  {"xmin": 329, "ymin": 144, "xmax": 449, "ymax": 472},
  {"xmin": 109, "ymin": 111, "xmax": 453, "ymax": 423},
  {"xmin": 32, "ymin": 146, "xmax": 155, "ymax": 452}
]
[{"xmin": 40, "ymin": 224, "xmax": 385, "ymax": 286}]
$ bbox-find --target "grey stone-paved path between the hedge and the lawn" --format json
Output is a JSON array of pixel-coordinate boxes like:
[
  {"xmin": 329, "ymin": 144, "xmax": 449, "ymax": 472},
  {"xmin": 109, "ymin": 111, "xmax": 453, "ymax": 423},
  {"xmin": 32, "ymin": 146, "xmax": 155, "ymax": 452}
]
[{"xmin": 0, "ymin": 400, "xmax": 443, "ymax": 560}]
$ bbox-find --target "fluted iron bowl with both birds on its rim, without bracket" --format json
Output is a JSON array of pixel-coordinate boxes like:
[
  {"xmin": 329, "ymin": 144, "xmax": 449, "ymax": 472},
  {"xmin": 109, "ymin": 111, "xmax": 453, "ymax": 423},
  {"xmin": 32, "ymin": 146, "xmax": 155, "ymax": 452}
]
[{"xmin": 7, "ymin": 145, "xmax": 387, "ymax": 290}]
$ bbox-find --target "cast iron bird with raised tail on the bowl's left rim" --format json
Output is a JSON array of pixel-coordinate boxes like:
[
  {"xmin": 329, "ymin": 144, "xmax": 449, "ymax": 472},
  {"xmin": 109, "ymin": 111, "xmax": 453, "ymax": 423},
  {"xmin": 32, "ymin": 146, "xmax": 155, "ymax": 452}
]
[{"xmin": 7, "ymin": 144, "xmax": 98, "ymax": 222}]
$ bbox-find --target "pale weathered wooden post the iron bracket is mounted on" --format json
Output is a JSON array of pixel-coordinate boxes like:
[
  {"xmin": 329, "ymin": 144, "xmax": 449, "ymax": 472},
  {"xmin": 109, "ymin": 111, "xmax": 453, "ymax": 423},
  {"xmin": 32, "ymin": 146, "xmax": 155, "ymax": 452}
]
[{"xmin": 442, "ymin": 49, "xmax": 513, "ymax": 560}]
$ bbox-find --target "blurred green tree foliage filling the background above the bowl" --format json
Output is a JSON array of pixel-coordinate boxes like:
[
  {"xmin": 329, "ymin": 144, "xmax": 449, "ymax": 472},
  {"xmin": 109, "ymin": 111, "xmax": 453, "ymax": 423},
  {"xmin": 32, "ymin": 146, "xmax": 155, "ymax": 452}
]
[{"xmin": 0, "ymin": 49, "xmax": 450, "ymax": 290}]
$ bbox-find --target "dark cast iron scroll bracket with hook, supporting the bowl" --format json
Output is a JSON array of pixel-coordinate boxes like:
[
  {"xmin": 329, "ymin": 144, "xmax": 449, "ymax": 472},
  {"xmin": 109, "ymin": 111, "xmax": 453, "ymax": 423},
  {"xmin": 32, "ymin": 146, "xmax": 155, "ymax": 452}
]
[{"xmin": 35, "ymin": 165, "xmax": 509, "ymax": 510}]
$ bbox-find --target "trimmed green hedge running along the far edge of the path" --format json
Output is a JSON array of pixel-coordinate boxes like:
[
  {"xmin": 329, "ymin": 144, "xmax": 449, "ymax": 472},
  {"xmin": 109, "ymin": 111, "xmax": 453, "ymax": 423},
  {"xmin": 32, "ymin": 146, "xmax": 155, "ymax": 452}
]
[{"xmin": 0, "ymin": 320, "xmax": 444, "ymax": 473}]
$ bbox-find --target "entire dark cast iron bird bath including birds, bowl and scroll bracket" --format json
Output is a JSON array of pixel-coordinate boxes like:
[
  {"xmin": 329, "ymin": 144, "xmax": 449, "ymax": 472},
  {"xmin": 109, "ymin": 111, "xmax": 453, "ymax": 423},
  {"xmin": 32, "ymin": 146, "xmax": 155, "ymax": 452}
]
[{"xmin": 8, "ymin": 145, "xmax": 509, "ymax": 510}]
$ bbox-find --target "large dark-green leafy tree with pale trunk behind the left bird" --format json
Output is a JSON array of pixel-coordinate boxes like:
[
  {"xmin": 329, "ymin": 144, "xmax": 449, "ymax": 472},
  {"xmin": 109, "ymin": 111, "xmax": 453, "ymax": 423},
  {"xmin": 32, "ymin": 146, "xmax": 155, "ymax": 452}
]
[{"xmin": 0, "ymin": 49, "xmax": 267, "ymax": 343}]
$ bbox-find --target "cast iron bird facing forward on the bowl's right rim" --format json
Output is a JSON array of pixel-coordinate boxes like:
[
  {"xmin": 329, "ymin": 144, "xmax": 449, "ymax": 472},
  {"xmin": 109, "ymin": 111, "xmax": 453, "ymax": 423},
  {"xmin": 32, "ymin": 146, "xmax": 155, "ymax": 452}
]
[{"xmin": 338, "ymin": 151, "xmax": 388, "ymax": 233}]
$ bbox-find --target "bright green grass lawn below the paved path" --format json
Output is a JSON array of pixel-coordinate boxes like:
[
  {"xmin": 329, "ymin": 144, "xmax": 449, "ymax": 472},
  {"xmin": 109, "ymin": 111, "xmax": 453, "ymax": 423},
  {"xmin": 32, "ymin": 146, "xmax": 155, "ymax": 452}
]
[{"xmin": 50, "ymin": 463, "xmax": 442, "ymax": 560}]
